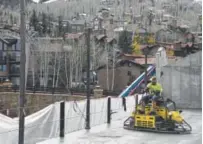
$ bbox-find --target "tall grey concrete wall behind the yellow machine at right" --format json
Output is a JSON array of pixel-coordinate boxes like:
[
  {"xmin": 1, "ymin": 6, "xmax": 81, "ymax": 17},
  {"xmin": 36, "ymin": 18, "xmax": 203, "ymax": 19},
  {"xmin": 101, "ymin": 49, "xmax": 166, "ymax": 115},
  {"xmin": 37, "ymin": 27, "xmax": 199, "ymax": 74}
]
[{"xmin": 160, "ymin": 52, "xmax": 202, "ymax": 108}]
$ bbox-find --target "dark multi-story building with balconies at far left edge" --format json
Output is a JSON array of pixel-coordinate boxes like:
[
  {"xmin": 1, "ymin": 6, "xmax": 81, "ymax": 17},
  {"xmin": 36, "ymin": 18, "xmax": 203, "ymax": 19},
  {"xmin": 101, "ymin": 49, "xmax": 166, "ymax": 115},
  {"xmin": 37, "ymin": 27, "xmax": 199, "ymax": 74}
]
[{"xmin": 0, "ymin": 37, "xmax": 20, "ymax": 85}]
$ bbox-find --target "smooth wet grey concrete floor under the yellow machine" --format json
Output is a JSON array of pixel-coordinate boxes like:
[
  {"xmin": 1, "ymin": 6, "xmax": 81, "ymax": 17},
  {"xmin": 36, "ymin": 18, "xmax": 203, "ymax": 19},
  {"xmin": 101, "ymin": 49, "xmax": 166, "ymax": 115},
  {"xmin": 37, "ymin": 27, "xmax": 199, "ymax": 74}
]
[{"xmin": 38, "ymin": 110, "xmax": 202, "ymax": 144}]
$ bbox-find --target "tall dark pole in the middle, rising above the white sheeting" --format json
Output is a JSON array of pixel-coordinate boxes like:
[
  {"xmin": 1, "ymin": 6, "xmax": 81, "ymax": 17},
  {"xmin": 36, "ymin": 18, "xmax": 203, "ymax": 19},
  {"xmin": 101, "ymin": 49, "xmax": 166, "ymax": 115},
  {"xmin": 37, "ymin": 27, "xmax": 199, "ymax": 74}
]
[{"xmin": 85, "ymin": 28, "xmax": 91, "ymax": 129}]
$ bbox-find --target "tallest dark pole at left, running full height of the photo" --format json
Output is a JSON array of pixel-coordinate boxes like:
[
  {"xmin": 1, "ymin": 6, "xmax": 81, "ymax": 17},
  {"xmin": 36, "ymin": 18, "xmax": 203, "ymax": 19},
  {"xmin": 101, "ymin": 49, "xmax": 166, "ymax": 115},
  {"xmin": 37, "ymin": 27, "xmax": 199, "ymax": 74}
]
[{"xmin": 18, "ymin": 0, "xmax": 26, "ymax": 144}]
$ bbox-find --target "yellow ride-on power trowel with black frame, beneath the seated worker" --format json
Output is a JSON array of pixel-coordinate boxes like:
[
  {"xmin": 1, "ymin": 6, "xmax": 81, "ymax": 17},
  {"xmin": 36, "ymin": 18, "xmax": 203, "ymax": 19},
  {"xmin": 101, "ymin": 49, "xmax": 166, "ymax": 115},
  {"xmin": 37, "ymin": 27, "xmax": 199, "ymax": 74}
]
[{"xmin": 124, "ymin": 92, "xmax": 192, "ymax": 134}]
